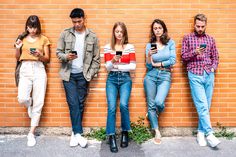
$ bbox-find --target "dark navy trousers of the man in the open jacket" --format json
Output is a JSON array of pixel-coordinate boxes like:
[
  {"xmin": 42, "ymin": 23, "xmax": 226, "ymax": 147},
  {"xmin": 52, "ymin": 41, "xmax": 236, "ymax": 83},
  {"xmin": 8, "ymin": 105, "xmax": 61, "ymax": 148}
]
[{"xmin": 63, "ymin": 73, "xmax": 88, "ymax": 134}]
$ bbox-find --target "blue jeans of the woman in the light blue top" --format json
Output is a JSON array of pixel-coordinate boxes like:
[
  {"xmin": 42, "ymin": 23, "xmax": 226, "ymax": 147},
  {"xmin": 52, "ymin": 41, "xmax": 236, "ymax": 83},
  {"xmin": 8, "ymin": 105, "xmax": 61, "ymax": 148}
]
[{"xmin": 144, "ymin": 68, "xmax": 171, "ymax": 129}]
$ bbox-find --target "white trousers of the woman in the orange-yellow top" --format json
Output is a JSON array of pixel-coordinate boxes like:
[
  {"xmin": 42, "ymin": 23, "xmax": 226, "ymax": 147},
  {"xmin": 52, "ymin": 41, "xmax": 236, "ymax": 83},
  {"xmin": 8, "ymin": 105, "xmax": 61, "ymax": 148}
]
[{"xmin": 18, "ymin": 61, "xmax": 47, "ymax": 126}]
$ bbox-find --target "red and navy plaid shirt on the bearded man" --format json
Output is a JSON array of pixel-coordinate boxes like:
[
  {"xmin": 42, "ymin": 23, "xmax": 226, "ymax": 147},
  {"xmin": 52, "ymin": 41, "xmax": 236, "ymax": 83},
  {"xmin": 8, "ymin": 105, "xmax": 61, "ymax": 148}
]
[{"xmin": 181, "ymin": 33, "xmax": 219, "ymax": 75}]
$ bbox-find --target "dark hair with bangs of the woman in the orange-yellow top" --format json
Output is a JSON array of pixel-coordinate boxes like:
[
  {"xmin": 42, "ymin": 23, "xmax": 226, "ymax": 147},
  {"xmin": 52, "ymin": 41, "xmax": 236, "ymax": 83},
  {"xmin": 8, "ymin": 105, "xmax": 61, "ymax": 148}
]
[{"xmin": 25, "ymin": 15, "xmax": 41, "ymax": 35}]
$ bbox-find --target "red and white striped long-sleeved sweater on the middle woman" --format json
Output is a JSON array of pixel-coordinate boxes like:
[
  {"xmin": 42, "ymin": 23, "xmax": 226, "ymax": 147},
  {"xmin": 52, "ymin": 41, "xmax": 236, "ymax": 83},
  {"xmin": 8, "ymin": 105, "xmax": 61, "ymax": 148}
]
[{"xmin": 104, "ymin": 44, "xmax": 136, "ymax": 72}]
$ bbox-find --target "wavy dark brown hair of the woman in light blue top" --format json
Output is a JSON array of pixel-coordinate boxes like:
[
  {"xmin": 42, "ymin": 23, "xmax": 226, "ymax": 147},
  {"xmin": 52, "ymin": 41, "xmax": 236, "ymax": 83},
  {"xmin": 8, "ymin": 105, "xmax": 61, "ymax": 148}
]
[{"xmin": 150, "ymin": 19, "xmax": 170, "ymax": 45}]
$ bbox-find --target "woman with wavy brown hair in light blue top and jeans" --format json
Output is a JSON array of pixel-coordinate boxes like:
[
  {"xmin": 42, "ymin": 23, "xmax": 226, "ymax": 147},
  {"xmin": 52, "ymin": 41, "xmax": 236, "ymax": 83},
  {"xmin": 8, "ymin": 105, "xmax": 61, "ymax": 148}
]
[{"xmin": 144, "ymin": 19, "xmax": 176, "ymax": 144}]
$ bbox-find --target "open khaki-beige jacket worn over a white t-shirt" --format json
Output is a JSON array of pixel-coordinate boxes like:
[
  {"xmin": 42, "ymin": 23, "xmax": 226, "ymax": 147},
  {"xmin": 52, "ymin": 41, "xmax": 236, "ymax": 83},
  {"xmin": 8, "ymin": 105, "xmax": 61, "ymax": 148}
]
[{"xmin": 56, "ymin": 27, "xmax": 100, "ymax": 81}]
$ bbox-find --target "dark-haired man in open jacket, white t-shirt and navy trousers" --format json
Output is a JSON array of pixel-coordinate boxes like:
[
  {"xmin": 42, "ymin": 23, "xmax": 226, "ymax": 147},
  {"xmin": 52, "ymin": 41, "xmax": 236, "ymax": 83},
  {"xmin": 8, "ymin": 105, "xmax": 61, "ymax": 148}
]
[{"xmin": 56, "ymin": 8, "xmax": 100, "ymax": 148}]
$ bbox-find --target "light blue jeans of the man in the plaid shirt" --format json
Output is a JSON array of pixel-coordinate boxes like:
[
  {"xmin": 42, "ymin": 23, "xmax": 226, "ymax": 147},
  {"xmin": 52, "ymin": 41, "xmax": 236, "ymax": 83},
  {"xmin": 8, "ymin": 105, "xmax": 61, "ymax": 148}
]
[{"xmin": 188, "ymin": 71, "xmax": 215, "ymax": 135}]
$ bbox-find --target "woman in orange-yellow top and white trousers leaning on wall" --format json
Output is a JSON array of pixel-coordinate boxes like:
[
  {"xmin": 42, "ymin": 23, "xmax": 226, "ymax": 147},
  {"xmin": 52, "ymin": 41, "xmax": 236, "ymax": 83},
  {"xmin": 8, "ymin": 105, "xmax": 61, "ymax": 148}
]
[{"xmin": 15, "ymin": 15, "xmax": 50, "ymax": 146}]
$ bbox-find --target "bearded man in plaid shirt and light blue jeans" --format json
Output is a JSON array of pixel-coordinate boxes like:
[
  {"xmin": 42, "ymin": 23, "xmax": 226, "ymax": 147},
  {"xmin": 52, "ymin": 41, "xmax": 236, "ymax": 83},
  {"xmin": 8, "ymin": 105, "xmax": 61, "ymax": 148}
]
[{"xmin": 181, "ymin": 14, "xmax": 220, "ymax": 147}]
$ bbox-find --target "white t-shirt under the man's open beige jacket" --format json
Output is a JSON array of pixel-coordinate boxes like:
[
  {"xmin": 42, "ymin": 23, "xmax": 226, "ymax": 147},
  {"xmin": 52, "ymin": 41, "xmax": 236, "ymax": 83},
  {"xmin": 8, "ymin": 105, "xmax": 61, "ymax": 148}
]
[{"xmin": 71, "ymin": 31, "xmax": 85, "ymax": 73}]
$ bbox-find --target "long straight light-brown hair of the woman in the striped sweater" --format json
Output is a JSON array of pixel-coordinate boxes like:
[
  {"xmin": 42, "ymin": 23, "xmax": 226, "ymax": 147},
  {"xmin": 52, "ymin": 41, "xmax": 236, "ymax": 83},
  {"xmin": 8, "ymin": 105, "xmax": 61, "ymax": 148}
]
[{"xmin": 111, "ymin": 22, "xmax": 129, "ymax": 50}]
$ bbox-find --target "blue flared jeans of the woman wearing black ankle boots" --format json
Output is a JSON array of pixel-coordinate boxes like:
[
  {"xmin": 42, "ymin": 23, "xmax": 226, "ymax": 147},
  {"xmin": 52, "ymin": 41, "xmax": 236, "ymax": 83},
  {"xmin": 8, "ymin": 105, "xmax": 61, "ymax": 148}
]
[{"xmin": 106, "ymin": 71, "xmax": 132, "ymax": 135}]
